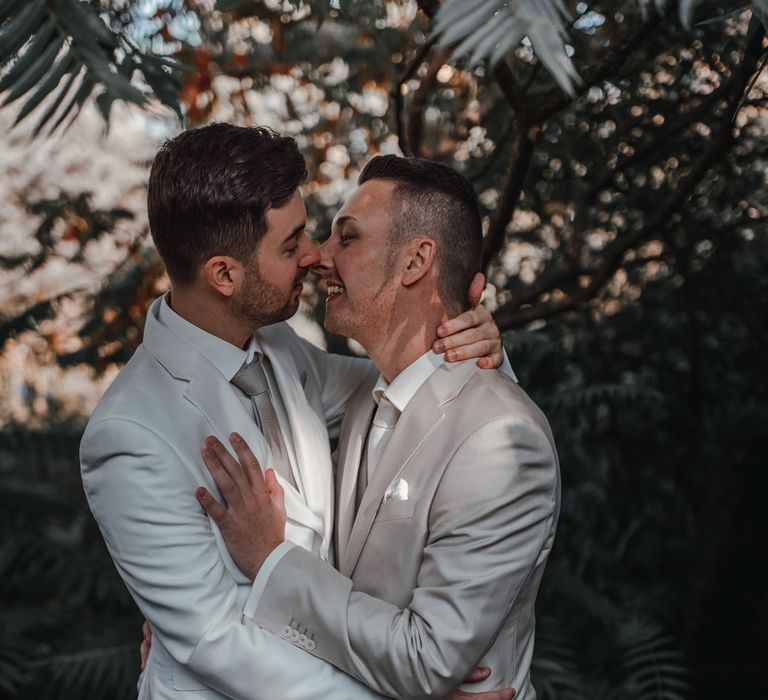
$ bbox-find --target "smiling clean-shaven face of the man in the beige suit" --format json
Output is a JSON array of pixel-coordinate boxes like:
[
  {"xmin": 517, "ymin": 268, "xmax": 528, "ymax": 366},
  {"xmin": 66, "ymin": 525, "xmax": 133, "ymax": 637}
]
[{"xmin": 315, "ymin": 180, "xmax": 398, "ymax": 346}]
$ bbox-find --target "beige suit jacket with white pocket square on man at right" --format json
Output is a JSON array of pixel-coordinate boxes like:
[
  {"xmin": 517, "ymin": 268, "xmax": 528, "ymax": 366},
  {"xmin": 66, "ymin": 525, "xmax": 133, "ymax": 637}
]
[{"xmin": 245, "ymin": 361, "xmax": 560, "ymax": 700}]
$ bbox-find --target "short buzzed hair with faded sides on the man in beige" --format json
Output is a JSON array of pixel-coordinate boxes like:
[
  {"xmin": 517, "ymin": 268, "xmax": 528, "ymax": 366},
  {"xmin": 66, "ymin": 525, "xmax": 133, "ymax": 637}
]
[{"xmin": 358, "ymin": 155, "xmax": 483, "ymax": 310}]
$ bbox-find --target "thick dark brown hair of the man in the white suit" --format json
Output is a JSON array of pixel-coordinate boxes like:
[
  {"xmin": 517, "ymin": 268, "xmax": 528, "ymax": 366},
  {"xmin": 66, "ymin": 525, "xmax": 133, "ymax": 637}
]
[{"xmin": 147, "ymin": 124, "xmax": 307, "ymax": 284}]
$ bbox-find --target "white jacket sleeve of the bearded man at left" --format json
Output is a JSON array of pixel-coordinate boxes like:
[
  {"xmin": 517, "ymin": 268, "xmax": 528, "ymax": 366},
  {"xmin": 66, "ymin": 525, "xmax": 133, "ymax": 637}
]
[{"xmin": 81, "ymin": 418, "xmax": 379, "ymax": 700}]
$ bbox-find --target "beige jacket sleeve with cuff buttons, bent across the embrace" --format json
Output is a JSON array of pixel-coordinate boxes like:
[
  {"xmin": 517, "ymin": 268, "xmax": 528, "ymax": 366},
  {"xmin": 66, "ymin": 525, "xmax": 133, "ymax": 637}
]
[{"xmin": 246, "ymin": 419, "xmax": 557, "ymax": 698}]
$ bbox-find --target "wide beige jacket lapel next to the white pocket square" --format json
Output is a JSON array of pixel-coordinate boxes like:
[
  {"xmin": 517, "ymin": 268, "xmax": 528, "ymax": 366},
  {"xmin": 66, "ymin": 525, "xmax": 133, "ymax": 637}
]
[{"xmin": 340, "ymin": 360, "xmax": 480, "ymax": 576}]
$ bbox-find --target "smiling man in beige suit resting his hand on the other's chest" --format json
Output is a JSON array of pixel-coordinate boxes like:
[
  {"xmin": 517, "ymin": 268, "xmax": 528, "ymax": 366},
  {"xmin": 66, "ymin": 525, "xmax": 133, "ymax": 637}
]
[{"xmin": 200, "ymin": 156, "xmax": 560, "ymax": 700}]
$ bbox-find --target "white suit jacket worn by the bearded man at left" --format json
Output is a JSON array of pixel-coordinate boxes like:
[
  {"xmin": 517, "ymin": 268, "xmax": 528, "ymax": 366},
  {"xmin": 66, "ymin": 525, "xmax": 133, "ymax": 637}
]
[{"xmin": 81, "ymin": 300, "xmax": 378, "ymax": 700}]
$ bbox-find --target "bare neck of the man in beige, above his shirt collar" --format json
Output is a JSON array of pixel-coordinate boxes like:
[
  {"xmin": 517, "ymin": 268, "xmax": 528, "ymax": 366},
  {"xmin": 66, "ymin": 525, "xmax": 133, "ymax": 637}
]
[{"xmin": 360, "ymin": 304, "xmax": 445, "ymax": 382}]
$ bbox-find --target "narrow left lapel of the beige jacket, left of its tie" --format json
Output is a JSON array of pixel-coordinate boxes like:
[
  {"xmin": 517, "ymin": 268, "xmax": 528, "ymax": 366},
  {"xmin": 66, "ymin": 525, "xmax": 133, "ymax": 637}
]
[{"xmin": 336, "ymin": 394, "xmax": 376, "ymax": 562}]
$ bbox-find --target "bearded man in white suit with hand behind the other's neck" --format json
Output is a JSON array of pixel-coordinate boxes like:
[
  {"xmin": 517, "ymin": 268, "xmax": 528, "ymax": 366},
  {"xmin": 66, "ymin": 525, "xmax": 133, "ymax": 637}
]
[{"xmin": 81, "ymin": 124, "xmax": 510, "ymax": 700}]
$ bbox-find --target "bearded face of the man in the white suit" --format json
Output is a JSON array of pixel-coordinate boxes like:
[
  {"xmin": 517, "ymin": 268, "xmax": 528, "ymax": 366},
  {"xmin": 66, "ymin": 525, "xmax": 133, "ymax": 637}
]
[{"xmin": 232, "ymin": 190, "xmax": 318, "ymax": 327}]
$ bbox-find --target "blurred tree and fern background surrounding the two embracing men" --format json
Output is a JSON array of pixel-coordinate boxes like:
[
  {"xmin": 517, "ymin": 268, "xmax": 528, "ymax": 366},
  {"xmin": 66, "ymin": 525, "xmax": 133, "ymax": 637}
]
[{"xmin": 0, "ymin": 0, "xmax": 768, "ymax": 700}]
